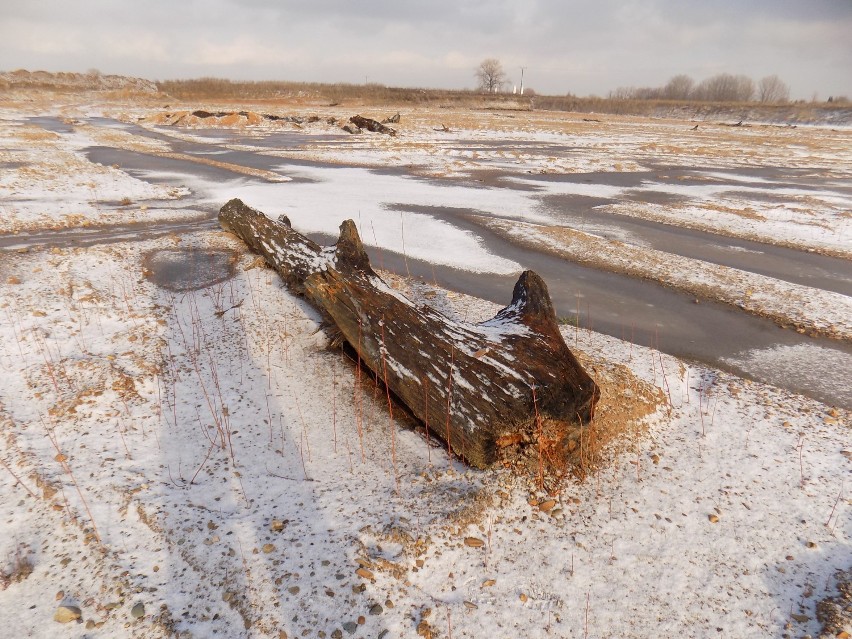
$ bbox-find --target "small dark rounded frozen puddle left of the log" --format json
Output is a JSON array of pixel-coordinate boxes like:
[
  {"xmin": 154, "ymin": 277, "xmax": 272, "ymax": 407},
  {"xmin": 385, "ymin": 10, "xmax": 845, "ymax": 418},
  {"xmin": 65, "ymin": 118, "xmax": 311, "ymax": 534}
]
[{"xmin": 143, "ymin": 249, "xmax": 237, "ymax": 292}]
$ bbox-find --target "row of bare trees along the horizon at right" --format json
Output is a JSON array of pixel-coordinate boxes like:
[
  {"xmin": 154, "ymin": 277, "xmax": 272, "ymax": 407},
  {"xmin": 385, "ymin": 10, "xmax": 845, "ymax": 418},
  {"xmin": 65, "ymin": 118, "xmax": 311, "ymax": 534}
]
[{"xmin": 609, "ymin": 73, "xmax": 790, "ymax": 104}]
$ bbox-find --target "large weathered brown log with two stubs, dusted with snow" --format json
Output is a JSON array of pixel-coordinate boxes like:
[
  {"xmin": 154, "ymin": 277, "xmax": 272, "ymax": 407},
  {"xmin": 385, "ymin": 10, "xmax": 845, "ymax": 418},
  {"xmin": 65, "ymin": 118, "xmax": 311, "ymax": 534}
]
[{"xmin": 219, "ymin": 199, "xmax": 600, "ymax": 468}]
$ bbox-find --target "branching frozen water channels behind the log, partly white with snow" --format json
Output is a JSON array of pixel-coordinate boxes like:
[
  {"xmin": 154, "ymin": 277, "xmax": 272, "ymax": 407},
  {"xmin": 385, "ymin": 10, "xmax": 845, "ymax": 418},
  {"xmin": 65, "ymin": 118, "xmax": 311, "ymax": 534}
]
[{"xmin": 16, "ymin": 119, "xmax": 852, "ymax": 408}]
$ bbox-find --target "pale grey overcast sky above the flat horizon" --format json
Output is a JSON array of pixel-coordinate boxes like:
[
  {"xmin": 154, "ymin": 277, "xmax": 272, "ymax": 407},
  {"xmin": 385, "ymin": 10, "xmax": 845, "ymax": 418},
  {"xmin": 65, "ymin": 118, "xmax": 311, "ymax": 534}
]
[{"xmin": 0, "ymin": 0, "xmax": 852, "ymax": 100}]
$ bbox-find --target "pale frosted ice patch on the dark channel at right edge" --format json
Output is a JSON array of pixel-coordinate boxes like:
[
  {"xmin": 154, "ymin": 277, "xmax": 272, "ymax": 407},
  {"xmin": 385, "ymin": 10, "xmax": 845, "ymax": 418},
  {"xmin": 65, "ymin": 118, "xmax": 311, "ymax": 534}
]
[{"xmin": 722, "ymin": 344, "xmax": 852, "ymax": 408}]
